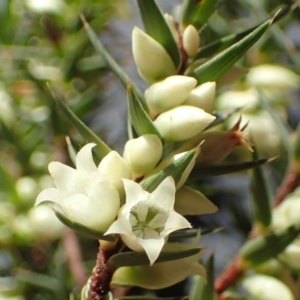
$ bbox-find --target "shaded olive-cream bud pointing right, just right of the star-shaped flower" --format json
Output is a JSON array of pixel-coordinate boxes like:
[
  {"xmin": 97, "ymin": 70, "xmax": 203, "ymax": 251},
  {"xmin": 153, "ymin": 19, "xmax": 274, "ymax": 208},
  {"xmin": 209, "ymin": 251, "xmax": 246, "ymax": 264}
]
[{"xmin": 175, "ymin": 186, "xmax": 218, "ymax": 215}]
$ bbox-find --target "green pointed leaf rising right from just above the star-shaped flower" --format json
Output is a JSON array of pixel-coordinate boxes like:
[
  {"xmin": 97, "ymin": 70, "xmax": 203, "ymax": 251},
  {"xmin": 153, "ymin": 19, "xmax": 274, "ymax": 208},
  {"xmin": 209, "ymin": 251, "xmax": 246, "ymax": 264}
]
[{"xmin": 140, "ymin": 148, "xmax": 199, "ymax": 193}]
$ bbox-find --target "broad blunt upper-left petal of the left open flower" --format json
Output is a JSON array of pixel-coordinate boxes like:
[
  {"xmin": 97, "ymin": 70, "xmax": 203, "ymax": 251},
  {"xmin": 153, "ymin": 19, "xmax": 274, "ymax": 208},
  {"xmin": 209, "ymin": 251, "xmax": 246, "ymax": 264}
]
[{"xmin": 48, "ymin": 161, "xmax": 77, "ymax": 195}]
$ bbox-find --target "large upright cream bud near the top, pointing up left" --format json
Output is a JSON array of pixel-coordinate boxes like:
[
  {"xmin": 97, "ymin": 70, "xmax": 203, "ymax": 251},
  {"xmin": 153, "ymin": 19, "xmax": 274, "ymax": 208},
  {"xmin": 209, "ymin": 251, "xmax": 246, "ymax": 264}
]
[{"xmin": 132, "ymin": 27, "xmax": 176, "ymax": 85}]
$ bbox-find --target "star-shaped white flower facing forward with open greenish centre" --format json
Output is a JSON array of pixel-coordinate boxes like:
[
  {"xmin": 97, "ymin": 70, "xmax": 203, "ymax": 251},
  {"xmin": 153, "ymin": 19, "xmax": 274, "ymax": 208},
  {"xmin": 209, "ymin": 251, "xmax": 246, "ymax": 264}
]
[{"xmin": 105, "ymin": 176, "xmax": 191, "ymax": 265}]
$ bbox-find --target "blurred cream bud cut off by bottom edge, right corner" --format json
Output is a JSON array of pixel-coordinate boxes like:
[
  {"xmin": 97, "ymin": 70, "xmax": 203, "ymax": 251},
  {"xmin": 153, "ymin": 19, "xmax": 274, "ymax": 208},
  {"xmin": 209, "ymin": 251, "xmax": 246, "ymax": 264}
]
[{"xmin": 242, "ymin": 274, "xmax": 295, "ymax": 300}]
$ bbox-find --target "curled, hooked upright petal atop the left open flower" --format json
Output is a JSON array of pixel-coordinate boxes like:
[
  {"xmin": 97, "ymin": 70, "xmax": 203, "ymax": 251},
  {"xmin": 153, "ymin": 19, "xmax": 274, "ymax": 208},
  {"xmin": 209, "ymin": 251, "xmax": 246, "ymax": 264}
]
[{"xmin": 76, "ymin": 143, "xmax": 98, "ymax": 173}]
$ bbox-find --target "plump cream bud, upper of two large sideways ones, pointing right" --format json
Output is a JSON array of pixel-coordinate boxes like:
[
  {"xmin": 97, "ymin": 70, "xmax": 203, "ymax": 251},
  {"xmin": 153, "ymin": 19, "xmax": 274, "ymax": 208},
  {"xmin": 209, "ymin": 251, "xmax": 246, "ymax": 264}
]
[{"xmin": 145, "ymin": 75, "xmax": 197, "ymax": 113}]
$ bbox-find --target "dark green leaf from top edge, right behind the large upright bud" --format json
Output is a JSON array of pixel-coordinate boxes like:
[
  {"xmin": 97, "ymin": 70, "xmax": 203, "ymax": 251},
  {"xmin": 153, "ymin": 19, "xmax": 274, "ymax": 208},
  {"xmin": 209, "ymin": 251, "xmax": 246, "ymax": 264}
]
[{"xmin": 137, "ymin": 0, "xmax": 181, "ymax": 68}]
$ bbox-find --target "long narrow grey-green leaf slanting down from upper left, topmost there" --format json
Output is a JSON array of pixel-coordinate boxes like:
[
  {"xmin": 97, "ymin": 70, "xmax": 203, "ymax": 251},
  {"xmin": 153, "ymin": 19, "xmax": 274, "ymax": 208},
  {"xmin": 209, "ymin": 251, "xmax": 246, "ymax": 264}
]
[{"xmin": 81, "ymin": 16, "xmax": 148, "ymax": 111}]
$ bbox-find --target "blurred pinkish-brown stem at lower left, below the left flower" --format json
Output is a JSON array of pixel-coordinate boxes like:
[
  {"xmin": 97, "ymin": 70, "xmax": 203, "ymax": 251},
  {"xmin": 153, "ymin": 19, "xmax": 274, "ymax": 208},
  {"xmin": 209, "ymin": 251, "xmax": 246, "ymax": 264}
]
[{"xmin": 63, "ymin": 228, "xmax": 87, "ymax": 288}]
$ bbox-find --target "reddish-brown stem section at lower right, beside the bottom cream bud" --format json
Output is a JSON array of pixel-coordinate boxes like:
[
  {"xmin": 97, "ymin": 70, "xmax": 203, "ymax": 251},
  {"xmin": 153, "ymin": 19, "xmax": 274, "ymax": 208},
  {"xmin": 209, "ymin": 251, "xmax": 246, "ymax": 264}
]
[{"xmin": 215, "ymin": 258, "xmax": 244, "ymax": 294}]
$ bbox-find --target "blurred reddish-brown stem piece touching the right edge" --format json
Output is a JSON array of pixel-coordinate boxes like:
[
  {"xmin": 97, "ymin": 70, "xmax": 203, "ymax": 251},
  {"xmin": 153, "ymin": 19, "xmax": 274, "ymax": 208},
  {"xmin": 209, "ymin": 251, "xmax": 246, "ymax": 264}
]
[{"xmin": 274, "ymin": 169, "xmax": 300, "ymax": 207}]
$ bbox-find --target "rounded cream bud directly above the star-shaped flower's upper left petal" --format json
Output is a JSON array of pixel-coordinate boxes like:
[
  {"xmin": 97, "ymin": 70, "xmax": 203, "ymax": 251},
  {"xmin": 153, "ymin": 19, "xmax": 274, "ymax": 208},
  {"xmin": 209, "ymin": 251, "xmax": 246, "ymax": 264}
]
[{"xmin": 123, "ymin": 134, "xmax": 163, "ymax": 176}]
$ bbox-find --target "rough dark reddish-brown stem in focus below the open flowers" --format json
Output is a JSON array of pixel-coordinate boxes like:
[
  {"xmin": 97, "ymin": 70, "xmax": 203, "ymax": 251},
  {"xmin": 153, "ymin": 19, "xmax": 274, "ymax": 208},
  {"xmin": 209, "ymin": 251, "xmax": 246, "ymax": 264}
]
[{"xmin": 86, "ymin": 239, "xmax": 120, "ymax": 300}]
